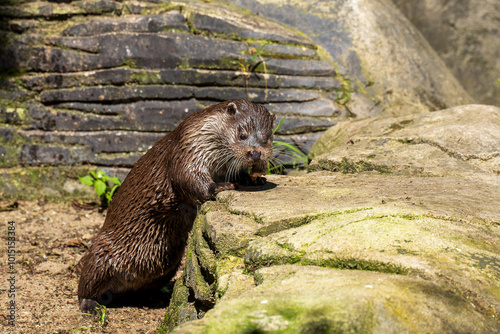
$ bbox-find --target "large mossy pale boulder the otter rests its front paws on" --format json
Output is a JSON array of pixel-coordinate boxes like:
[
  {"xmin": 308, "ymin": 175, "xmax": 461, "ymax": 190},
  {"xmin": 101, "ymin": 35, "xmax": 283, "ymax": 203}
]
[{"xmin": 167, "ymin": 172, "xmax": 500, "ymax": 333}]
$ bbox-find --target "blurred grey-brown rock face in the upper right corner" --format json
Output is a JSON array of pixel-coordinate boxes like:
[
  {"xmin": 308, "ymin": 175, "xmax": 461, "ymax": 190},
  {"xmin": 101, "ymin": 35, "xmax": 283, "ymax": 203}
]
[{"xmin": 392, "ymin": 0, "xmax": 500, "ymax": 106}]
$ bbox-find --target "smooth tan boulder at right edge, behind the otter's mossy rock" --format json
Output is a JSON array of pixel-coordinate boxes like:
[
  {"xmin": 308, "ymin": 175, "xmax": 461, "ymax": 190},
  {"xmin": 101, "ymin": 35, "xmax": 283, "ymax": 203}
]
[{"xmin": 310, "ymin": 105, "xmax": 500, "ymax": 176}]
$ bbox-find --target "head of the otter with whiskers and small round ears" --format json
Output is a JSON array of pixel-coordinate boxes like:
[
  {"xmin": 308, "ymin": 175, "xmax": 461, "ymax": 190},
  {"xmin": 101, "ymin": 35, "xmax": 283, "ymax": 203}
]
[{"xmin": 209, "ymin": 99, "xmax": 276, "ymax": 179}]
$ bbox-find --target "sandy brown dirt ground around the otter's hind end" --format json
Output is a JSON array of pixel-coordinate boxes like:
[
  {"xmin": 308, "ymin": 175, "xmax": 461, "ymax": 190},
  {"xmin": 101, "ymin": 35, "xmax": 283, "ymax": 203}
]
[{"xmin": 0, "ymin": 202, "xmax": 171, "ymax": 333}]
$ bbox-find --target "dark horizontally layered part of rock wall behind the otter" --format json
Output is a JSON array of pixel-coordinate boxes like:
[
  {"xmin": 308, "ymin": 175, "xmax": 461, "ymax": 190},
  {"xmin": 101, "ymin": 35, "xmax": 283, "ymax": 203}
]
[{"xmin": 0, "ymin": 1, "xmax": 346, "ymax": 172}]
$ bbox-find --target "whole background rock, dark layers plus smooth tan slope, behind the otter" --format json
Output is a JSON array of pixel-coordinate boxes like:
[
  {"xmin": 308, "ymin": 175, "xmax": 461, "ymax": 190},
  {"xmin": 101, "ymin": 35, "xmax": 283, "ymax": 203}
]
[{"xmin": 0, "ymin": 0, "xmax": 471, "ymax": 196}]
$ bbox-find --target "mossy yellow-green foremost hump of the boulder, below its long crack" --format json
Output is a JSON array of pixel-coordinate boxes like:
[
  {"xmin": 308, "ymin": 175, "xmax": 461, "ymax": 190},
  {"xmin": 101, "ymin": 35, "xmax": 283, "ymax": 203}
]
[{"xmin": 173, "ymin": 266, "xmax": 498, "ymax": 333}]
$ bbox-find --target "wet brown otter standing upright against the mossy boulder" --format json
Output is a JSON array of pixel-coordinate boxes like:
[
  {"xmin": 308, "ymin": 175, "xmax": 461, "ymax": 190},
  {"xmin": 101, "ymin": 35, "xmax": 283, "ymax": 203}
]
[{"xmin": 77, "ymin": 99, "xmax": 276, "ymax": 314}]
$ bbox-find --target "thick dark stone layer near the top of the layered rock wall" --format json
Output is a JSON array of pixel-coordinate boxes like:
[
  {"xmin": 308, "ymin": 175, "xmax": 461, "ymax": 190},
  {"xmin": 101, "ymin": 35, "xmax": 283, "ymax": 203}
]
[{"xmin": 29, "ymin": 33, "xmax": 247, "ymax": 72}]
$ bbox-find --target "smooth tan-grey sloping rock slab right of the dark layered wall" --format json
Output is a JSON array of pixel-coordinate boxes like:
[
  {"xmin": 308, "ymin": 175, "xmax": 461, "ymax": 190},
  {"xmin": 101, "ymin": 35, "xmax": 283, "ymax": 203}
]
[{"xmin": 231, "ymin": 0, "xmax": 472, "ymax": 114}]
